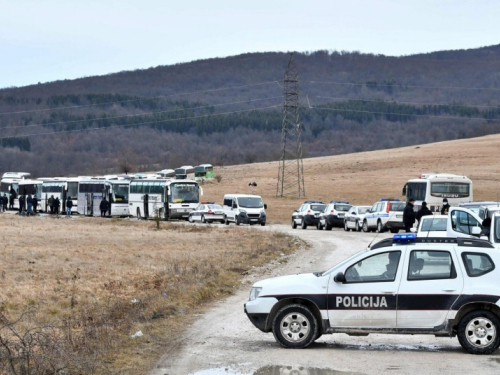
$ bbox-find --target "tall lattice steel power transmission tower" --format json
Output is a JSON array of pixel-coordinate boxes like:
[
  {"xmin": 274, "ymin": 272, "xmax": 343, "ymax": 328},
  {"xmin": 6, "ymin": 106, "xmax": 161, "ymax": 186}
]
[{"xmin": 276, "ymin": 54, "xmax": 305, "ymax": 198}]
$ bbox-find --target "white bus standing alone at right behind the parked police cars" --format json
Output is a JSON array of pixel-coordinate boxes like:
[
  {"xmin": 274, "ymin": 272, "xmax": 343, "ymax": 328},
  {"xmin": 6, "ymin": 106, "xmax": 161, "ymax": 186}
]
[{"xmin": 402, "ymin": 173, "xmax": 474, "ymax": 212}]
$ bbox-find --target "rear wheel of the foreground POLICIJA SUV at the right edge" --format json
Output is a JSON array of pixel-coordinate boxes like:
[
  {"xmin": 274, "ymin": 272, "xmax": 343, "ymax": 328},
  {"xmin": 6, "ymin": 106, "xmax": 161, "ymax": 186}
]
[{"xmin": 457, "ymin": 310, "xmax": 500, "ymax": 354}]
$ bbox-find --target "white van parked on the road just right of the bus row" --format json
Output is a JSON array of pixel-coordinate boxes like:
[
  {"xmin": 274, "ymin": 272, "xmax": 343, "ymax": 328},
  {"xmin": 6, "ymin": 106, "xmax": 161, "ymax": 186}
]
[{"xmin": 223, "ymin": 194, "xmax": 267, "ymax": 226}]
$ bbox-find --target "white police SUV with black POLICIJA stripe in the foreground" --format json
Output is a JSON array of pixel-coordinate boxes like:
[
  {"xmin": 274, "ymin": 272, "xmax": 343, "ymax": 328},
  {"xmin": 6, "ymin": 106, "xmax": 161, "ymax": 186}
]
[{"xmin": 245, "ymin": 233, "xmax": 500, "ymax": 354}]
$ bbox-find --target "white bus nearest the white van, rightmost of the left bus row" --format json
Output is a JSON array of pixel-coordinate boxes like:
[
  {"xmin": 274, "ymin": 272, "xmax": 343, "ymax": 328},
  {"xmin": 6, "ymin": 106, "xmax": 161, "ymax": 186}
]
[{"xmin": 129, "ymin": 178, "xmax": 203, "ymax": 220}]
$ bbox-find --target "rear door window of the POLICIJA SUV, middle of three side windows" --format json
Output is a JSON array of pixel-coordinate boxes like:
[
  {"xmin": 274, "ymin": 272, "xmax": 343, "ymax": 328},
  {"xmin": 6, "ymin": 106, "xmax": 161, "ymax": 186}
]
[{"xmin": 408, "ymin": 250, "xmax": 457, "ymax": 280}]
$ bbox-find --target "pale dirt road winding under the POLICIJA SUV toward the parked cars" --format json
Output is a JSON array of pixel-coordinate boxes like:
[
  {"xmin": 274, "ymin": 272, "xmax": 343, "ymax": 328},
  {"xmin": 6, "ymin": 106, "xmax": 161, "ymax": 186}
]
[{"xmin": 152, "ymin": 225, "xmax": 500, "ymax": 375}]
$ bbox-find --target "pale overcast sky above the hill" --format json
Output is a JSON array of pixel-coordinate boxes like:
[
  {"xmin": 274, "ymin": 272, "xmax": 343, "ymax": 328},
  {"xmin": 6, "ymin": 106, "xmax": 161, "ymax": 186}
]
[{"xmin": 0, "ymin": 0, "xmax": 500, "ymax": 88}]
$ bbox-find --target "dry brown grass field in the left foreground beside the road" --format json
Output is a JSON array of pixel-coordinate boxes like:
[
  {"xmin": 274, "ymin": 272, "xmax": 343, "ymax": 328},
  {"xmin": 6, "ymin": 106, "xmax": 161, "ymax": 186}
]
[{"xmin": 0, "ymin": 214, "xmax": 302, "ymax": 374}]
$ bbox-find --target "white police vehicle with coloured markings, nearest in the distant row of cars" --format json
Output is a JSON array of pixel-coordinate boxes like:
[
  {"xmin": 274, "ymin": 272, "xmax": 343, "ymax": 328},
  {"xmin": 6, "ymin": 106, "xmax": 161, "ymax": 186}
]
[{"xmin": 363, "ymin": 198, "xmax": 405, "ymax": 233}]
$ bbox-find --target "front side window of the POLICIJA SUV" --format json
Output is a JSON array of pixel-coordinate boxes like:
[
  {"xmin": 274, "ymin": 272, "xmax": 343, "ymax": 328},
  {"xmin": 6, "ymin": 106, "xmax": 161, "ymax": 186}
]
[{"xmin": 345, "ymin": 251, "xmax": 401, "ymax": 283}]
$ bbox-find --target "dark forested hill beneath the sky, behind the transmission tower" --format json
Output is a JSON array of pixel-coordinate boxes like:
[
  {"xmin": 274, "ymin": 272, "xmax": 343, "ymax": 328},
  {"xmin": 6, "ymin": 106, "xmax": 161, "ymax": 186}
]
[{"xmin": 0, "ymin": 45, "xmax": 500, "ymax": 176}]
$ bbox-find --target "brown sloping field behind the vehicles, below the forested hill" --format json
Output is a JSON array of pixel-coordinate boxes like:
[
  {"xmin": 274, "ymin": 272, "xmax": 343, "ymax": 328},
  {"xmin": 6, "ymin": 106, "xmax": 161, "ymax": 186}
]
[{"xmin": 203, "ymin": 134, "xmax": 500, "ymax": 223}]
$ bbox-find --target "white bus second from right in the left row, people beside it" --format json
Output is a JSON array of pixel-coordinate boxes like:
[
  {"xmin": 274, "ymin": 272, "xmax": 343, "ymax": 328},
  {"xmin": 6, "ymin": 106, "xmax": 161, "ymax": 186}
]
[{"xmin": 77, "ymin": 178, "xmax": 130, "ymax": 216}]
